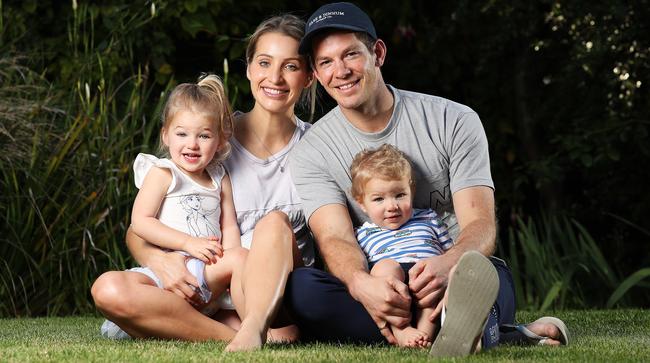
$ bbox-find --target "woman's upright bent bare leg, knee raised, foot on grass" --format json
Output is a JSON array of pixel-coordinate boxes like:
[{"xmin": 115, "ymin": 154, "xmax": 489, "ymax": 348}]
[{"xmin": 226, "ymin": 211, "xmax": 301, "ymax": 351}]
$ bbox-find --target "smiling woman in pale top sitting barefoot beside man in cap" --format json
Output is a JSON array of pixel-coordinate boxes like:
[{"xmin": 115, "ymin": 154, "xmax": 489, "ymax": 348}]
[{"xmin": 92, "ymin": 15, "xmax": 313, "ymax": 350}]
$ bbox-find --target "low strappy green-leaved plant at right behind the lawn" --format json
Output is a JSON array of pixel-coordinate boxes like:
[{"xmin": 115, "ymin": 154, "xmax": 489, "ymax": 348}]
[{"xmin": 502, "ymin": 216, "xmax": 650, "ymax": 311}]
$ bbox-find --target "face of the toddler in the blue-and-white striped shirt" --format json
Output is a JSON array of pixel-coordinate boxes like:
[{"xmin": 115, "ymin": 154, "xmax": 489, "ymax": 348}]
[{"xmin": 360, "ymin": 178, "xmax": 413, "ymax": 229}]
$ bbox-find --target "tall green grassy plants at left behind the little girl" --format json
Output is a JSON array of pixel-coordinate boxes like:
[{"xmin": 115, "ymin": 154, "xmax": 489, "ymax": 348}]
[{"xmin": 0, "ymin": 2, "xmax": 166, "ymax": 316}]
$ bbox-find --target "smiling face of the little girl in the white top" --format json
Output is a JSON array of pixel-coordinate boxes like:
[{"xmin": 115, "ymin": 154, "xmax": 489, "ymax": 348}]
[{"xmin": 162, "ymin": 110, "xmax": 222, "ymax": 180}]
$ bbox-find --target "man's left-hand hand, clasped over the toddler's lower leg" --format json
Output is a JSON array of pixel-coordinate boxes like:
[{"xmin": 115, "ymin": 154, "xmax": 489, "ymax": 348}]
[{"xmin": 350, "ymin": 273, "xmax": 411, "ymax": 344}]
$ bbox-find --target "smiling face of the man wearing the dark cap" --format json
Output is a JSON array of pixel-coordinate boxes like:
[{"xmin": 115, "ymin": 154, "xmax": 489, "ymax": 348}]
[{"xmin": 312, "ymin": 32, "xmax": 385, "ymax": 110}]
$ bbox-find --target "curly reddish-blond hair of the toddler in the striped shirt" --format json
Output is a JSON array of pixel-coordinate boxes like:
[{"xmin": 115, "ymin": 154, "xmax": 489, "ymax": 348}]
[{"xmin": 350, "ymin": 144, "xmax": 415, "ymax": 201}]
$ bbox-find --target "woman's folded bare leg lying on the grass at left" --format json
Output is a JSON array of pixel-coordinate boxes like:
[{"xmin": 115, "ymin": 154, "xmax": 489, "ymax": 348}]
[{"xmin": 91, "ymin": 271, "xmax": 235, "ymax": 341}]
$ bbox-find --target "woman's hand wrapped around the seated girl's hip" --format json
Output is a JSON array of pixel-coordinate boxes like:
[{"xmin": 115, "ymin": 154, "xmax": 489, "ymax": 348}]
[{"xmin": 148, "ymin": 252, "xmax": 203, "ymax": 306}]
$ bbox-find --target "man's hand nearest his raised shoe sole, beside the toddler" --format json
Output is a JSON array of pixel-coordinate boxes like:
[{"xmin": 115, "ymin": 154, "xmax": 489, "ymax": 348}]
[{"xmin": 409, "ymin": 254, "xmax": 456, "ymax": 308}]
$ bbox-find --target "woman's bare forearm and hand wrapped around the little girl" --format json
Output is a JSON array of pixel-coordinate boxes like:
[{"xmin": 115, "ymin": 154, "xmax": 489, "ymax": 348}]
[{"xmin": 126, "ymin": 227, "xmax": 200, "ymax": 304}]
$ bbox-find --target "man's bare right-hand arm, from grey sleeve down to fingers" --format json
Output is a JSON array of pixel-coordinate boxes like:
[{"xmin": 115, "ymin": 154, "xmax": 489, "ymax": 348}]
[{"xmin": 409, "ymin": 186, "xmax": 496, "ymax": 307}]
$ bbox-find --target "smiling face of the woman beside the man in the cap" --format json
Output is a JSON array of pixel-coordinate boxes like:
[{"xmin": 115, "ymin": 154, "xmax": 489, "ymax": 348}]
[{"xmin": 246, "ymin": 33, "xmax": 312, "ymax": 113}]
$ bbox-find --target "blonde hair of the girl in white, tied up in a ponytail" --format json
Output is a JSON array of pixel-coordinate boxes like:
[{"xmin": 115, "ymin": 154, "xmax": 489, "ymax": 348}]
[{"xmin": 159, "ymin": 74, "xmax": 233, "ymax": 161}]
